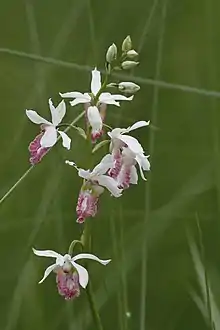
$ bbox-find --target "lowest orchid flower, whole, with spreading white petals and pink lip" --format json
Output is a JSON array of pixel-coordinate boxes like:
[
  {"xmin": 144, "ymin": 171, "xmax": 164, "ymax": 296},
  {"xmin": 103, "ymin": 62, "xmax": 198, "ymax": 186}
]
[{"xmin": 33, "ymin": 249, "xmax": 111, "ymax": 299}]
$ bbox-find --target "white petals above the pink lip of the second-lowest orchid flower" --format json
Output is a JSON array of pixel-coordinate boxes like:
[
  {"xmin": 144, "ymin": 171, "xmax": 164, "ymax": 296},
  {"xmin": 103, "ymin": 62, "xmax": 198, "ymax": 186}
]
[{"xmin": 66, "ymin": 154, "xmax": 122, "ymax": 197}]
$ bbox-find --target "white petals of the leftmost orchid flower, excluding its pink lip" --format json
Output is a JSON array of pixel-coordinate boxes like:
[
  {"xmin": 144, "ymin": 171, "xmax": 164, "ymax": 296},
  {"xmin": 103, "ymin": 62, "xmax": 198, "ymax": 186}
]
[{"xmin": 26, "ymin": 99, "xmax": 71, "ymax": 149}]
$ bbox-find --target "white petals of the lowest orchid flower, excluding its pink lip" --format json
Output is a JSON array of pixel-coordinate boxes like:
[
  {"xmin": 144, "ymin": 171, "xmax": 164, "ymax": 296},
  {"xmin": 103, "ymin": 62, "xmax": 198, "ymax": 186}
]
[{"xmin": 33, "ymin": 249, "xmax": 111, "ymax": 288}]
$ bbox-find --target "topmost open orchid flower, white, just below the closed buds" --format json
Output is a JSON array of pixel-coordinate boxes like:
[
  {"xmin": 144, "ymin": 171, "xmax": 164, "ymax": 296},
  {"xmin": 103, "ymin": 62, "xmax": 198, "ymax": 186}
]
[{"xmin": 60, "ymin": 68, "xmax": 133, "ymax": 141}]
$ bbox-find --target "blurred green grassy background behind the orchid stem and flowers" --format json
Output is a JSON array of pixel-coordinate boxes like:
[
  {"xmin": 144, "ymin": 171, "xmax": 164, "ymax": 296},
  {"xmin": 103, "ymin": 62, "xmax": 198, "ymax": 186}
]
[{"xmin": 0, "ymin": 0, "xmax": 220, "ymax": 330}]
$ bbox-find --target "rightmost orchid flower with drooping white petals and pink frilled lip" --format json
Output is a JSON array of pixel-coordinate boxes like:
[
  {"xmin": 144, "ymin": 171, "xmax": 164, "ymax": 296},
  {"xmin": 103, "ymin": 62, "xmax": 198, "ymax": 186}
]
[{"xmin": 108, "ymin": 121, "xmax": 150, "ymax": 178}]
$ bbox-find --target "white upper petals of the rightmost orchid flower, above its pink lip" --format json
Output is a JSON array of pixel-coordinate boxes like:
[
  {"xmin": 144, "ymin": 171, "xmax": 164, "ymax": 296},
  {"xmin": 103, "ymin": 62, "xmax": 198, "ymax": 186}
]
[{"xmin": 108, "ymin": 120, "xmax": 150, "ymax": 153}]
